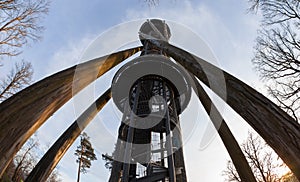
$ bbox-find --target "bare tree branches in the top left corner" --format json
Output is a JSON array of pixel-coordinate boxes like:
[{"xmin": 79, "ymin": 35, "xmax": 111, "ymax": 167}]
[{"xmin": 0, "ymin": 0, "xmax": 49, "ymax": 57}]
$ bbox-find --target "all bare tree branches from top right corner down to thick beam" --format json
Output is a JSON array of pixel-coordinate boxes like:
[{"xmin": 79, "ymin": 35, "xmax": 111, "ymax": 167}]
[{"xmin": 250, "ymin": 0, "xmax": 300, "ymax": 121}]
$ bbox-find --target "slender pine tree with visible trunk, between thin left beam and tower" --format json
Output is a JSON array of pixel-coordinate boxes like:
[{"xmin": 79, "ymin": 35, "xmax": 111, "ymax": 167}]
[{"xmin": 75, "ymin": 132, "xmax": 97, "ymax": 182}]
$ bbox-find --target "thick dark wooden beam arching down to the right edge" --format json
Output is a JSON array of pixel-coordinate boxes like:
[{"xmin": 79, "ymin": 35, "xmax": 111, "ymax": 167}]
[{"xmin": 151, "ymin": 40, "xmax": 300, "ymax": 180}]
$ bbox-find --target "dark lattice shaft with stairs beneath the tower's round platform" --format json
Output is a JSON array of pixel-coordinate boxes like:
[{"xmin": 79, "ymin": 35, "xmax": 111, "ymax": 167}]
[{"xmin": 111, "ymin": 77, "xmax": 186, "ymax": 182}]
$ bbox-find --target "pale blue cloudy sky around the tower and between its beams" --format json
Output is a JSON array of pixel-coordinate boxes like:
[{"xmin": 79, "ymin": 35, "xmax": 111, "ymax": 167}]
[{"xmin": 0, "ymin": 0, "xmax": 272, "ymax": 182}]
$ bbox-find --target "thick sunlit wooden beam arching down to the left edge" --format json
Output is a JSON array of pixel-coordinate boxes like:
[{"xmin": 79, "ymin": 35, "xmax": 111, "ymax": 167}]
[{"xmin": 0, "ymin": 47, "xmax": 140, "ymax": 176}]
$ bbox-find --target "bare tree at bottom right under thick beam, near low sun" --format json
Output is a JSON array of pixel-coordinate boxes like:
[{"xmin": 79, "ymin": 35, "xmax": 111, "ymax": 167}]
[{"xmin": 223, "ymin": 133, "xmax": 285, "ymax": 182}]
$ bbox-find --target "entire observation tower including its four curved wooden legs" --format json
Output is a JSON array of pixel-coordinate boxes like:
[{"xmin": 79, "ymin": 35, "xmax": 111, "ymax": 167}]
[{"xmin": 0, "ymin": 20, "xmax": 300, "ymax": 182}]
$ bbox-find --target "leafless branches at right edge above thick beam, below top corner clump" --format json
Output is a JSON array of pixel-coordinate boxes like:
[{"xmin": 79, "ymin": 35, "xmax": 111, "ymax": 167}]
[{"xmin": 252, "ymin": 23, "xmax": 300, "ymax": 120}]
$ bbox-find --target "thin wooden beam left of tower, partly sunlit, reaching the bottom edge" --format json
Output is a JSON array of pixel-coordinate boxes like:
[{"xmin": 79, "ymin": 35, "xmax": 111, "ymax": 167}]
[{"xmin": 25, "ymin": 89, "xmax": 111, "ymax": 182}]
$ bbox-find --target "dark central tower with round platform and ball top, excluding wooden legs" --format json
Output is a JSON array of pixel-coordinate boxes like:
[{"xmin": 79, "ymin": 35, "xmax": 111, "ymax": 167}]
[{"xmin": 109, "ymin": 20, "xmax": 191, "ymax": 182}]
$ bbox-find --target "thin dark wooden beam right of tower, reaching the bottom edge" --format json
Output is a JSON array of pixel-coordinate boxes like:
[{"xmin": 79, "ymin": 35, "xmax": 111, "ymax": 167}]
[{"xmin": 191, "ymin": 75, "xmax": 256, "ymax": 182}]
